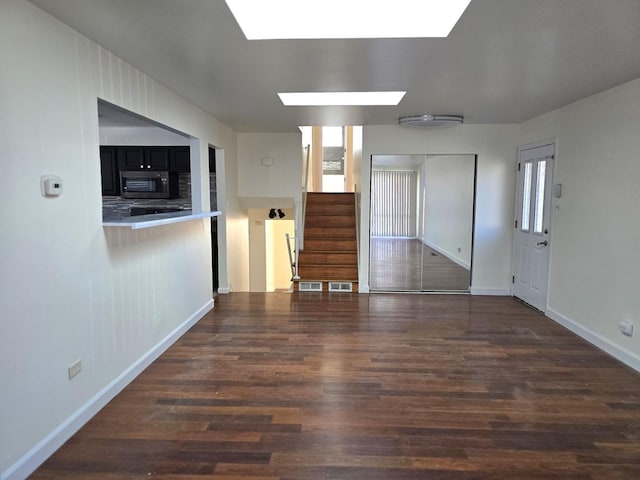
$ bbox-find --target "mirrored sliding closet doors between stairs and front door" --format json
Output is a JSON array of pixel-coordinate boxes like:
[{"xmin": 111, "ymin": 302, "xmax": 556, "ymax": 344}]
[{"xmin": 369, "ymin": 154, "xmax": 476, "ymax": 292}]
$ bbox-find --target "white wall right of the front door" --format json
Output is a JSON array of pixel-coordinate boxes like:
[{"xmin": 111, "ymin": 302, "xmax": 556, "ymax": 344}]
[{"xmin": 520, "ymin": 79, "xmax": 640, "ymax": 369}]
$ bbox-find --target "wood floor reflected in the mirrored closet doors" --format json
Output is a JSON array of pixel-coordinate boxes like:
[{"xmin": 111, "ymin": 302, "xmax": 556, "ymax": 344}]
[{"xmin": 369, "ymin": 238, "xmax": 471, "ymax": 292}]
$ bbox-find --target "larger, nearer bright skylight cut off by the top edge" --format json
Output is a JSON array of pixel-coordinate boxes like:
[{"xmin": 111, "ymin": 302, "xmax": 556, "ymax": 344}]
[{"xmin": 226, "ymin": 0, "xmax": 471, "ymax": 40}]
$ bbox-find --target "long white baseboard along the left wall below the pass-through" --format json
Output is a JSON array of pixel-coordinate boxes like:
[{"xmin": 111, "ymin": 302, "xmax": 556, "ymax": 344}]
[{"xmin": 0, "ymin": 299, "xmax": 214, "ymax": 480}]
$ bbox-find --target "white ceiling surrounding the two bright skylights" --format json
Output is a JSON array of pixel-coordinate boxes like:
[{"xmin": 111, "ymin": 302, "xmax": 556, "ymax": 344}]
[{"xmin": 31, "ymin": 0, "xmax": 640, "ymax": 132}]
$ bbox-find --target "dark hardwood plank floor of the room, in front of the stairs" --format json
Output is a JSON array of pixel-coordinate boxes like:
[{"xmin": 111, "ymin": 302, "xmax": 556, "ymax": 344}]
[{"xmin": 33, "ymin": 293, "xmax": 640, "ymax": 480}]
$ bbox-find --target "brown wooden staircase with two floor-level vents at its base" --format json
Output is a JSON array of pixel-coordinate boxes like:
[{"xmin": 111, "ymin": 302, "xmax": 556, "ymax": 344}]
[{"xmin": 294, "ymin": 193, "xmax": 358, "ymax": 292}]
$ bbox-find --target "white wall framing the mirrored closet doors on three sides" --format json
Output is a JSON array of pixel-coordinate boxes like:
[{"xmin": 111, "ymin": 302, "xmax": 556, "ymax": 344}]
[{"xmin": 359, "ymin": 125, "xmax": 519, "ymax": 295}]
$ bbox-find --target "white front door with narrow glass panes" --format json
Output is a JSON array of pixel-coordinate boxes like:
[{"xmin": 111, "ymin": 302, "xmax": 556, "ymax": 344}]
[{"xmin": 513, "ymin": 145, "xmax": 555, "ymax": 312}]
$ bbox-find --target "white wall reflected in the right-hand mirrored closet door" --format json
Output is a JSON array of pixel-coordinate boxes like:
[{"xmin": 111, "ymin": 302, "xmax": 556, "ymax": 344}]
[{"xmin": 420, "ymin": 155, "xmax": 475, "ymax": 269}]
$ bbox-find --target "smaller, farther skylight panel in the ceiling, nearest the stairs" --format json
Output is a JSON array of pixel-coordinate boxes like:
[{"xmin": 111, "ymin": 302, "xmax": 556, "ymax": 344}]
[{"xmin": 278, "ymin": 92, "xmax": 407, "ymax": 106}]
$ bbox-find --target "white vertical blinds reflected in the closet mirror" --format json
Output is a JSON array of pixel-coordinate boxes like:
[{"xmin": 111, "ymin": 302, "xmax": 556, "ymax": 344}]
[{"xmin": 371, "ymin": 170, "xmax": 418, "ymax": 238}]
